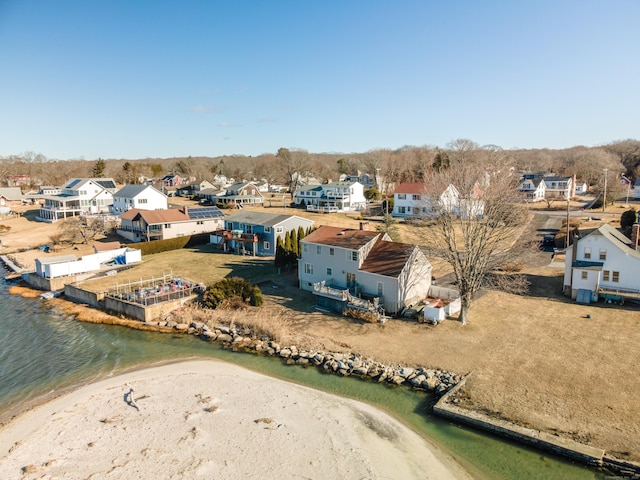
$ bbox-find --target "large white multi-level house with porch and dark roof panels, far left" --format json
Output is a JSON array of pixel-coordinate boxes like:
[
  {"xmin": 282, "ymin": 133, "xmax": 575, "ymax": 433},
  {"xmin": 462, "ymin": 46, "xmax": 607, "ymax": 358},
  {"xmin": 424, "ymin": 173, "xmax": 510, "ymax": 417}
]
[{"xmin": 38, "ymin": 178, "xmax": 117, "ymax": 222}]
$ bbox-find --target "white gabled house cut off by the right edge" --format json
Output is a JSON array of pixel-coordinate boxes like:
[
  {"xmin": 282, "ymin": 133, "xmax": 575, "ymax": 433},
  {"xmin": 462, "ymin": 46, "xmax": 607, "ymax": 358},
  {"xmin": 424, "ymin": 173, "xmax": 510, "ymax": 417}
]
[{"xmin": 564, "ymin": 224, "xmax": 640, "ymax": 303}]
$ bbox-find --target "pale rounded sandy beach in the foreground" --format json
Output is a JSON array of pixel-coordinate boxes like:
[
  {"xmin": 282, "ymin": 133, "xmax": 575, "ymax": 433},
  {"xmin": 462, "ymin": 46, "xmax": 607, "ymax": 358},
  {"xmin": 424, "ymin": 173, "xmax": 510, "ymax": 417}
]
[{"xmin": 0, "ymin": 360, "xmax": 470, "ymax": 479}]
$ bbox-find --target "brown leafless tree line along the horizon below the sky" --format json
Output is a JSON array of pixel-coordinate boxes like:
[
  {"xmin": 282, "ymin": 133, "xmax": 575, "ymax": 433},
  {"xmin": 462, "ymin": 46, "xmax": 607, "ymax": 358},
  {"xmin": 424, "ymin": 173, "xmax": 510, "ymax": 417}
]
[{"xmin": 0, "ymin": 139, "xmax": 640, "ymax": 193}]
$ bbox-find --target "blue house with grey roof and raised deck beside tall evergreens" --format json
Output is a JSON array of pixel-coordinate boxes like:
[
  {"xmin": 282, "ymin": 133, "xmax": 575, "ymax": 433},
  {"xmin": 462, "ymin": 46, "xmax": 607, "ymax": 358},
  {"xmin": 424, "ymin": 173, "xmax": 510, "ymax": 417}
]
[{"xmin": 211, "ymin": 210, "xmax": 314, "ymax": 256}]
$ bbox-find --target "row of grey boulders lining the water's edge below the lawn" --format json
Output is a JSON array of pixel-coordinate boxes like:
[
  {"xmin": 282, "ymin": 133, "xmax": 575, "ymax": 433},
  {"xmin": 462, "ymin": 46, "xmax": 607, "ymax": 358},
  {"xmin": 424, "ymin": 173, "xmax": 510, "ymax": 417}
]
[{"xmin": 162, "ymin": 321, "xmax": 463, "ymax": 396}]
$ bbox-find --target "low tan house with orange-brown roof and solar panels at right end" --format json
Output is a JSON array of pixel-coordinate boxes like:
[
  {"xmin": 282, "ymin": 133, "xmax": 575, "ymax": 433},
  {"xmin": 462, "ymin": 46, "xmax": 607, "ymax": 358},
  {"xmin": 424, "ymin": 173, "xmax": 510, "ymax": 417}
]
[{"xmin": 117, "ymin": 207, "xmax": 224, "ymax": 242}]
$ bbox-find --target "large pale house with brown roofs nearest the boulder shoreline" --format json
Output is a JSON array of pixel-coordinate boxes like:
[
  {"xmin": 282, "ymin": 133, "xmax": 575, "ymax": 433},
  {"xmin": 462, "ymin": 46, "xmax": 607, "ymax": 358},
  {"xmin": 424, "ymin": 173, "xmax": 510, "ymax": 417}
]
[{"xmin": 298, "ymin": 224, "xmax": 432, "ymax": 313}]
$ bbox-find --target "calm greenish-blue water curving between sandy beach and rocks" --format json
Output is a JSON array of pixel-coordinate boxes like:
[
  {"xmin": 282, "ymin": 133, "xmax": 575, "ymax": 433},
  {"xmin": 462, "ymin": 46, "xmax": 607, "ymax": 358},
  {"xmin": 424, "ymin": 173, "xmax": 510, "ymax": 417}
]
[{"xmin": 0, "ymin": 270, "xmax": 611, "ymax": 479}]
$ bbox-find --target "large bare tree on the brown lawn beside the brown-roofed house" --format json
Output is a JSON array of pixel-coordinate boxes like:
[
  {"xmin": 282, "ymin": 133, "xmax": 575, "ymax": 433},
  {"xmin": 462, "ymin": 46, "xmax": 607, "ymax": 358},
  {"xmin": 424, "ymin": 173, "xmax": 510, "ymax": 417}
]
[{"xmin": 425, "ymin": 152, "xmax": 526, "ymax": 324}]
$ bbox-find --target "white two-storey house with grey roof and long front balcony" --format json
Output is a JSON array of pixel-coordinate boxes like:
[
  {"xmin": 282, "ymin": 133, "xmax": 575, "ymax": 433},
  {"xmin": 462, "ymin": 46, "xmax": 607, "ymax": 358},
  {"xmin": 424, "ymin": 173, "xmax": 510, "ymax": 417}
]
[{"xmin": 293, "ymin": 182, "xmax": 367, "ymax": 213}]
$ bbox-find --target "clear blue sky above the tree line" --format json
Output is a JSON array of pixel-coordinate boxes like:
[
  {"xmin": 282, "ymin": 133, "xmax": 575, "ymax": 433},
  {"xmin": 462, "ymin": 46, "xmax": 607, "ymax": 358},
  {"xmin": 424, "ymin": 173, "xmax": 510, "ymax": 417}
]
[{"xmin": 0, "ymin": 0, "xmax": 640, "ymax": 159}]
